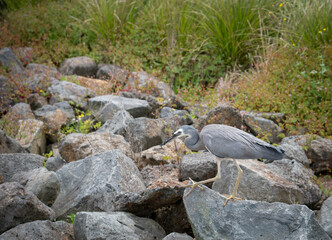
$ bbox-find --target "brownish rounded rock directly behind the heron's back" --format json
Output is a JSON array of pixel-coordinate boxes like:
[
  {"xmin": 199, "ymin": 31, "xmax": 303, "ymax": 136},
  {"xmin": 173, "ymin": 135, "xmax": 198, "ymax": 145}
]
[{"xmin": 197, "ymin": 104, "xmax": 243, "ymax": 130}]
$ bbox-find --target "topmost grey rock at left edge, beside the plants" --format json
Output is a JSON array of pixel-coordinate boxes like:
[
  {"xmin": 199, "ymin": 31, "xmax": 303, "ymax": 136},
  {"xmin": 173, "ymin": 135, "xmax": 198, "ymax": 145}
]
[{"xmin": 0, "ymin": 47, "xmax": 24, "ymax": 73}]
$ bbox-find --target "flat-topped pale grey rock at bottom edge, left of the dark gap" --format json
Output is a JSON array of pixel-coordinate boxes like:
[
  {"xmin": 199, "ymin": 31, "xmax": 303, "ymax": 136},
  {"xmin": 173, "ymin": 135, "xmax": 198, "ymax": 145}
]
[{"xmin": 74, "ymin": 212, "xmax": 166, "ymax": 240}]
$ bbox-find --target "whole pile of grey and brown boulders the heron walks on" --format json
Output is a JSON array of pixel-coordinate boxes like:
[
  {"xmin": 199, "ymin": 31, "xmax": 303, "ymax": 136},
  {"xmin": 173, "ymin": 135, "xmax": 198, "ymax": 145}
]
[{"xmin": 0, "ymin": 48, "xmax": 332, "ymax": 240}]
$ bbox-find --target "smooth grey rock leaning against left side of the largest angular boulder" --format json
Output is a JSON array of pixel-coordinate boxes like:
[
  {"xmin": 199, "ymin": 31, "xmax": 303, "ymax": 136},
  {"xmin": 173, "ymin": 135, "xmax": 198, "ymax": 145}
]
[{"xmin": 11, "ymin": 168, "xmax": 60, "ymax": 206}]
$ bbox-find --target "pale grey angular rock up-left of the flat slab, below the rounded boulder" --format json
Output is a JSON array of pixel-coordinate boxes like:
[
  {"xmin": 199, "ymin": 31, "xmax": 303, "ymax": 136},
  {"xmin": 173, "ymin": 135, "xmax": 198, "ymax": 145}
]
[{"xmin": 48, "ymin": 81, "xmax": 95, "ymax": 110}]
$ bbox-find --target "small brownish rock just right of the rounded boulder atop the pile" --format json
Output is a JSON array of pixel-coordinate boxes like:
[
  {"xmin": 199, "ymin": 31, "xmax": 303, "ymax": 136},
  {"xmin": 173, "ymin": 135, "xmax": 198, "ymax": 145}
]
[{"xmin": 97, "ymin": 64, "xmax": 129, "ymax": 85}]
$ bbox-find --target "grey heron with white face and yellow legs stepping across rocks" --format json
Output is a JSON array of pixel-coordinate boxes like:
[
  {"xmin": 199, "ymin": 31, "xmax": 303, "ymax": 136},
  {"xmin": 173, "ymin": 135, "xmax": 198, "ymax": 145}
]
[{"xmin": 161, "ymin": 124, "xmax": 284, "ymax": 206}]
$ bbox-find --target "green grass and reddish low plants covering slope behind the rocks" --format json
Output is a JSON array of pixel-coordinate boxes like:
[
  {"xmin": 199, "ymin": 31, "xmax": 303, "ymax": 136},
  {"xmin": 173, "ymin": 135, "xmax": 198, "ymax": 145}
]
[{"xmin": 0, "ymin": 0, "xmax": 332, "ymax": 137}]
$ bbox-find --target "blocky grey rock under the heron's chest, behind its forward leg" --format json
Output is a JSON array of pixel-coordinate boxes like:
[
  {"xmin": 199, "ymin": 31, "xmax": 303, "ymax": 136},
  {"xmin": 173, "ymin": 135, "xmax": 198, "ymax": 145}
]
[{"xmin": 179, "ymin": 152, "xmax": 217, "ymax": 184}]
